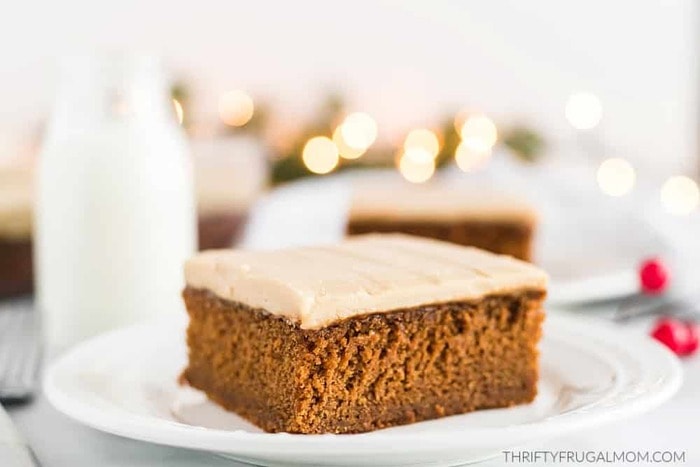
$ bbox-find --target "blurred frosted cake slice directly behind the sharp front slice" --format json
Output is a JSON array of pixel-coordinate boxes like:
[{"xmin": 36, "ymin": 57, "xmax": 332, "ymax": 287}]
[{"xmin": 347, "ymin": 182, "xmax": 537, "ymax": 261}]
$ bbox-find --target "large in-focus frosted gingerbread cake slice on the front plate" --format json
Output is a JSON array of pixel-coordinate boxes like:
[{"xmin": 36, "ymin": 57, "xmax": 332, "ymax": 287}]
[{"xmin": 182, "ymin": 234, "xmax": 547, "ymax": 433}]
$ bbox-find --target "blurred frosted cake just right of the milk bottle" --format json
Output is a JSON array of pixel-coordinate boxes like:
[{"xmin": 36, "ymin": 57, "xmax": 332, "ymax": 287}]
[{"xmin": 192, "ymin": 137, "xmax": 267, "ymax": 250}]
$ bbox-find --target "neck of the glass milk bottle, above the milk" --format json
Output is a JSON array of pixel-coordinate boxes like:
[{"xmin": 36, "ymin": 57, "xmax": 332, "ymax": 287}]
[{"xmin": 49, "ymin": 55, "xmax": 175, "ymax": 137}]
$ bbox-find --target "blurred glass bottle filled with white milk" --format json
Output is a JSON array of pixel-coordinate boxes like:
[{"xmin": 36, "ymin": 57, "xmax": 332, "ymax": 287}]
[{"xmin": 35, "ymin": 56, "xmax": 196, "ymax": 349}]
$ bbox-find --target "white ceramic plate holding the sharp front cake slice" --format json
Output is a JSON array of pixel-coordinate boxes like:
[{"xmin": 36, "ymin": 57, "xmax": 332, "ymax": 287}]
[{"xmin": 44, "ymin": 316, "xmax": 681, "ymax": 466}]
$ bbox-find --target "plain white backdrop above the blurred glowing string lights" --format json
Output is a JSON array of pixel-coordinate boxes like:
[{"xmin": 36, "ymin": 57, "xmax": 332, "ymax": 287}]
[{"xmin": 0, "ymin": 0, "xmax": 698, "ymax": 174}]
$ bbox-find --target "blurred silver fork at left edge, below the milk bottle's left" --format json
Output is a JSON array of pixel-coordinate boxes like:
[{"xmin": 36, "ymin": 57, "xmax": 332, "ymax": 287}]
[{"xmin": 0, "ymin": 299, "xmax": 41, "ymax": 403}]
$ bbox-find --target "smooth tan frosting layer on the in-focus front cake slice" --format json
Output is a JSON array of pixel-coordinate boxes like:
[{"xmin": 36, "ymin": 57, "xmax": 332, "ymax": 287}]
[{"xmin": 185, "ymin": 234, "xmax": 547, "ymax": 329}]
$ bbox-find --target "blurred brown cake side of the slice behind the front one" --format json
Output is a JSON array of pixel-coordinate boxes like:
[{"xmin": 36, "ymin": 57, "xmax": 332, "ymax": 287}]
[{"xmin": 347, "ymin": 219, "xmax": 534, "ymax": 261}]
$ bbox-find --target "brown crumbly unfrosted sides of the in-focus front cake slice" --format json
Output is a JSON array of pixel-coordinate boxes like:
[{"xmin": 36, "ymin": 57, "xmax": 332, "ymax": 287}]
[{"xmin": 183, "ymin": 287, "xmax": 545, "ymax": 433}]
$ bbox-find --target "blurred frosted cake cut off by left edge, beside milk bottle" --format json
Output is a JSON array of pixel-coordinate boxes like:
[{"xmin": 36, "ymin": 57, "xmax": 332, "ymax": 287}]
[{"xmin": 0, "ymin": 162, "xmax": 34, "ymax": 298}]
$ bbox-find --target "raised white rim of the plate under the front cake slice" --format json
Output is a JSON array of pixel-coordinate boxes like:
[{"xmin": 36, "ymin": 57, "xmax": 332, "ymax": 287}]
[{"xmin": 43, "ymin": 313, "xmax": 683, "ymax": 456}]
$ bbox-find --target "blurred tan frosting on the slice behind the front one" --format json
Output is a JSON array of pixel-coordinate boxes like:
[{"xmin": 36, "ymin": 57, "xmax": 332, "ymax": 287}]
[{"xmin": 350, "ymin": 182, "xmax": 537, "ymax": 223}]
